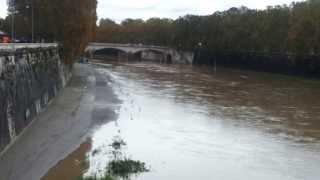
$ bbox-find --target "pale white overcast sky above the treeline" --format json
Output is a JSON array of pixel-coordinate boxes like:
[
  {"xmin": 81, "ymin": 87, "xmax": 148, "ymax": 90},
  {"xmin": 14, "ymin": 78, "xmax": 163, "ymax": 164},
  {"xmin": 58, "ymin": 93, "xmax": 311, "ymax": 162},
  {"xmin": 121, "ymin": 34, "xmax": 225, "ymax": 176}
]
[{"xmin": 0, "ymin": 0, "xmax": 300, "ymax": 22}]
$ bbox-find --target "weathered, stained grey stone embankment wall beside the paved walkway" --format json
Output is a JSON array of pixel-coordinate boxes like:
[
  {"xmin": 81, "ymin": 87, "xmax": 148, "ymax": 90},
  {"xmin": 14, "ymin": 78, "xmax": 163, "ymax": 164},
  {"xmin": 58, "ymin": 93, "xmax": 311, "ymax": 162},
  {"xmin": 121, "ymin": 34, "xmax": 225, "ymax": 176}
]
[{"xmin": 0, "ymin": 47, "xmax": 71, "ymax": 152}]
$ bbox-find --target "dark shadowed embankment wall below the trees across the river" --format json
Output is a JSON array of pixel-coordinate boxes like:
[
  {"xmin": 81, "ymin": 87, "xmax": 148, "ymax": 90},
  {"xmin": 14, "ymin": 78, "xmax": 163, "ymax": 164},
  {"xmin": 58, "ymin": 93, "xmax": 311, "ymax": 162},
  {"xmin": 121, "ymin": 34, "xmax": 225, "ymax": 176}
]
[{"xmin": 194, "ymin": 51, "xmax": 320, "ymax": 78}]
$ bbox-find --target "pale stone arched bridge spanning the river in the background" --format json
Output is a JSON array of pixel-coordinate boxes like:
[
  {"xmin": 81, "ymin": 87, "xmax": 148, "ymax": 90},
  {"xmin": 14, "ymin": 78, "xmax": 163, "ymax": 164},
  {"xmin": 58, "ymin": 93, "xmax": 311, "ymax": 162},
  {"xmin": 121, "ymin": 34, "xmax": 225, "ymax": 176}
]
[{"xmin": 86, "ymin": 43, "xmax": 194, "ymax": 64}]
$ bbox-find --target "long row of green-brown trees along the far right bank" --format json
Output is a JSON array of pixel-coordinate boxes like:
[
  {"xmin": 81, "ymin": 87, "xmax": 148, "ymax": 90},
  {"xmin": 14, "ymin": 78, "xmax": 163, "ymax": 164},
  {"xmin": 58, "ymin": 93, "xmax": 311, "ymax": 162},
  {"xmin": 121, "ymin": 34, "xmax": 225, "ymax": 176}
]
[{"xmin": 97, "ymin": 0, "xmax": 320, "ymax": 54}]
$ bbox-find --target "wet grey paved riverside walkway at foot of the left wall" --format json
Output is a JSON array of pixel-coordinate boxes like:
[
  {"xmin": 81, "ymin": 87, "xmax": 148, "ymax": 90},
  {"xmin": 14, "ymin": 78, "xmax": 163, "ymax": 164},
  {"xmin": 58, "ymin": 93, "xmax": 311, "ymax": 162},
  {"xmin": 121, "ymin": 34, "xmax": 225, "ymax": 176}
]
[{"xmin": 0, "ymin": 64, "xmax": 120, "ymax": 180}]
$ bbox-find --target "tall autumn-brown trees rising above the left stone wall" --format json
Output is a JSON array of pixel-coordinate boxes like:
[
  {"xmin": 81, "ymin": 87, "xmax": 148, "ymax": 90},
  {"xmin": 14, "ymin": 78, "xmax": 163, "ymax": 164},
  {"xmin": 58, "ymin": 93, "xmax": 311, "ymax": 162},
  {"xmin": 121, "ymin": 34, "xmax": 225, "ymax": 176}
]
[{"xmin": 0, "ymin": 0, "xmax": 97, "ymax": 64}]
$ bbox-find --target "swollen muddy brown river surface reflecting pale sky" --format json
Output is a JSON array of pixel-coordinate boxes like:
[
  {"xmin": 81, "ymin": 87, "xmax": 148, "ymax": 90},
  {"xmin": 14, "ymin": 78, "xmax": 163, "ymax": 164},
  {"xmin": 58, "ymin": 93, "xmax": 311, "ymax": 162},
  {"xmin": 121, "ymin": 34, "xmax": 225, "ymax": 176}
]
[{"xmin": 44, "ymin": 63, "xmax": 320, "ymax": 180}]
